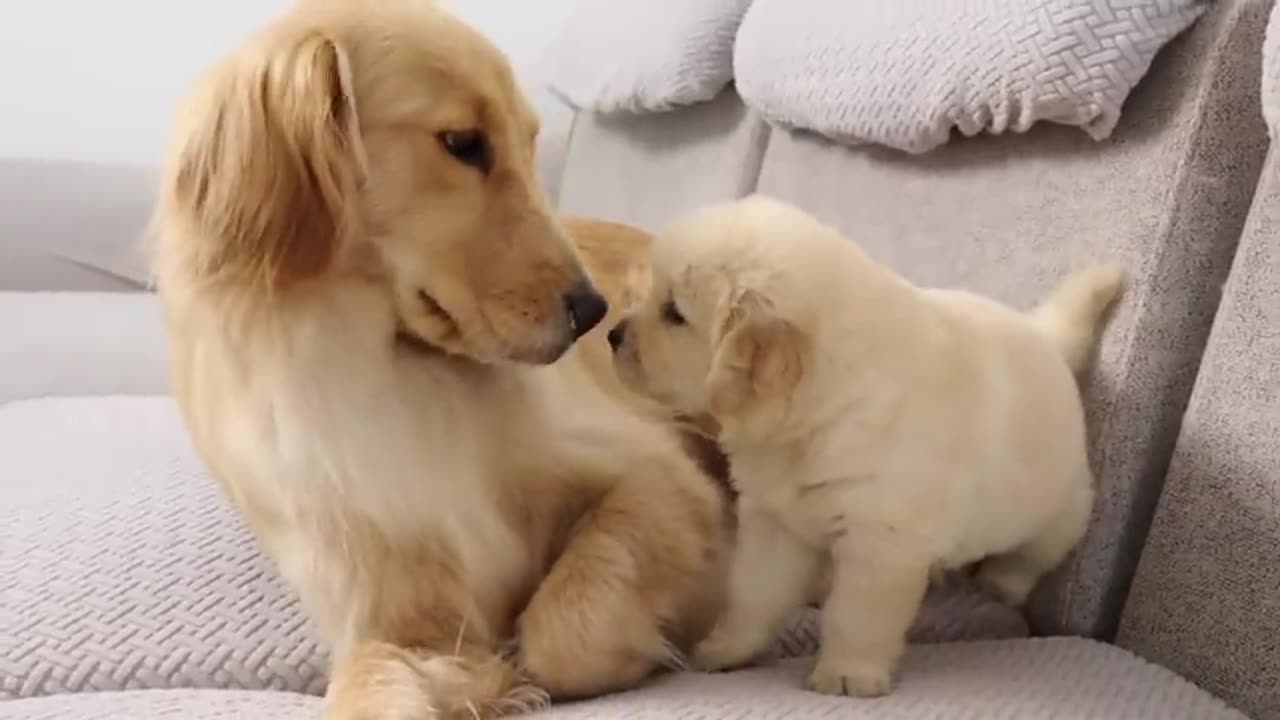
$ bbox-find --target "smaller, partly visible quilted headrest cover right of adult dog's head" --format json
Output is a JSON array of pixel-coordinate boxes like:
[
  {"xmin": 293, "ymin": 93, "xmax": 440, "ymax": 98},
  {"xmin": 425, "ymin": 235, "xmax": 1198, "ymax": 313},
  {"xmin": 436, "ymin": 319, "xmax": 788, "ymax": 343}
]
[{"xmin": 544, "ymin": 0, "xmax": 751, "ymax": 113}]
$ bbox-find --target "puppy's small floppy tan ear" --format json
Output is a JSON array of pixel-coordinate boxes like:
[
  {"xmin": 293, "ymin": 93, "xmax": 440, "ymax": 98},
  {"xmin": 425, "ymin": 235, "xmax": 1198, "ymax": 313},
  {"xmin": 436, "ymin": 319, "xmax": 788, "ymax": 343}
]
[{"xmin": 707, "ymin": 291, "xmax": 808, "ymax": 418}]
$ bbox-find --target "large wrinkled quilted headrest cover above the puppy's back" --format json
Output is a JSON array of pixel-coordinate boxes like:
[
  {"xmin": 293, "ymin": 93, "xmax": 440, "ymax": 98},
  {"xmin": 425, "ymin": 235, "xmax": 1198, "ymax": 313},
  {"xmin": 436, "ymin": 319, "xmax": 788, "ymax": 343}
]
[{"xmin": 733, "ymin": 0, "xmax": 1208, "ymax": 152}]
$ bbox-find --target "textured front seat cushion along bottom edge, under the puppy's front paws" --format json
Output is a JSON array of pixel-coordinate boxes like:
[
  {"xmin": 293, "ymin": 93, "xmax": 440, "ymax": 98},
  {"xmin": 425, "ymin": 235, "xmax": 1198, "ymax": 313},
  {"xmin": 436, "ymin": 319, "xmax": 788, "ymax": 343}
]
[{"xmin": 0, "ymin": 638, "xmax": 1248, "ymax": 720}]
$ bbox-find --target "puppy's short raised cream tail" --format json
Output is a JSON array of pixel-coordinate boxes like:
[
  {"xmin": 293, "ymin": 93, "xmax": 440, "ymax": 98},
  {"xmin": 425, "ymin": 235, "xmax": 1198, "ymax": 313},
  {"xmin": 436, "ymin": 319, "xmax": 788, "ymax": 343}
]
[{"xmin": 1030, "ymin": 264, "xmax": 1129, "ymax": 375}]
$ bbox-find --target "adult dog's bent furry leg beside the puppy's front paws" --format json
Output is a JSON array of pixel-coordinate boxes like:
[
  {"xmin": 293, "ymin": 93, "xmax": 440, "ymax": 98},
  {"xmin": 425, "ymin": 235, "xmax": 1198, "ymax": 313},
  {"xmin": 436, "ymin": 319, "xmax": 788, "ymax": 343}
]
[{"xmin": 517, "ymin": 451, "xmax": 727, "ymax": 698}]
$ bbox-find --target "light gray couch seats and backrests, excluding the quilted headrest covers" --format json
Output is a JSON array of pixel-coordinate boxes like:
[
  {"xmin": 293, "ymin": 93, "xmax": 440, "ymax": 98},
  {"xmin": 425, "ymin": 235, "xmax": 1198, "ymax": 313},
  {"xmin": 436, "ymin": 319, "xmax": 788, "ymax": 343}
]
[{"xmin": 0, "ymin": 0, "xmax": 1280, "ymax": 720}]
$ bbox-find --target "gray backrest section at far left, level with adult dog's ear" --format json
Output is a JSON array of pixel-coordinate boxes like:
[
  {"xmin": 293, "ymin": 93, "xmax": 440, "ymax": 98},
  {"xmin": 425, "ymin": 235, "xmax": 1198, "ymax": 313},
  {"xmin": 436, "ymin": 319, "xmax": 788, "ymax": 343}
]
[{"xmin": 0, "ymin": 159, "xmax": 152, "ymax": 291}]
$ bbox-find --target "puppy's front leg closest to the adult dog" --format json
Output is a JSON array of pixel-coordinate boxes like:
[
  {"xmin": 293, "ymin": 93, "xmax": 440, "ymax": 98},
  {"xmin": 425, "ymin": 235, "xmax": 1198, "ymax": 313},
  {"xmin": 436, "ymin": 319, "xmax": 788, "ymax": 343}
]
[{"xmin": 694, "ymin": 501, "xmax": 822, "ymax": 670}]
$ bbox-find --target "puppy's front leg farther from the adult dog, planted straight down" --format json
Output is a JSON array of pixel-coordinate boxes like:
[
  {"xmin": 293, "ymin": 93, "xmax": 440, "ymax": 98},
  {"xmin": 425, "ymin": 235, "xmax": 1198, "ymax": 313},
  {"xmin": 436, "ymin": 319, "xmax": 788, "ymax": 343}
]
[{"xmin": 808, "ymin": 530, "xmax": 931, "ymax": 697}]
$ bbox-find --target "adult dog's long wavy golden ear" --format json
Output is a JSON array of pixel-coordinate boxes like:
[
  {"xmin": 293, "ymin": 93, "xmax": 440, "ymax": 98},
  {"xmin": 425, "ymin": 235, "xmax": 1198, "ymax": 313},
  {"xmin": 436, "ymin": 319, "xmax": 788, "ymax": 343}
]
[{"xmin": 168, "ymin": 31, "xmax": 364, "ymax": 287}]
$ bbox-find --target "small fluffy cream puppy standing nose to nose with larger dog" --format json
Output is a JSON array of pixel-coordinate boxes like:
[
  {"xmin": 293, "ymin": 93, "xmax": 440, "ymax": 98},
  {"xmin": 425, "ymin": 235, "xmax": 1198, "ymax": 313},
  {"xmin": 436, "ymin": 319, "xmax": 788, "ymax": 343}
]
[{"xmin": 609, "ymin": 196, "xmax": 1125, "ymax": 697}]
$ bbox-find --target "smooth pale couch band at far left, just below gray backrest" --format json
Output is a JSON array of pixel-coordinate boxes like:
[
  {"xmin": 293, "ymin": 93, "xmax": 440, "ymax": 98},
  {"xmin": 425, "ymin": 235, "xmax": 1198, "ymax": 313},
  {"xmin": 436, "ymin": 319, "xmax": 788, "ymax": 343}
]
[{"xmin": 0, "ymin": 292, "xmax": 169, "ymax": 405}]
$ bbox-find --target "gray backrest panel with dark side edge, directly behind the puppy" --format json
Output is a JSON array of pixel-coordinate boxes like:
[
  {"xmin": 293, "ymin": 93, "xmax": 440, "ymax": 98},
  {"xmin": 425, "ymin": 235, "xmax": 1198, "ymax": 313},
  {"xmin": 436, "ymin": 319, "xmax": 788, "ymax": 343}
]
[{"xmin": 759, "ymin": 0, "xmax": 1271, "ymax": 638}]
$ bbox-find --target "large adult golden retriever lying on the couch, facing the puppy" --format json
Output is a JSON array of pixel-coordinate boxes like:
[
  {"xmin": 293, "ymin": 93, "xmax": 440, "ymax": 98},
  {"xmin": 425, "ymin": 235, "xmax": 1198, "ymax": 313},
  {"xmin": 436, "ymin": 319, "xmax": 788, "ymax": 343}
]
[{"xmin": 154, "ymin": 0, "xmax": 724, "ymax": 720}]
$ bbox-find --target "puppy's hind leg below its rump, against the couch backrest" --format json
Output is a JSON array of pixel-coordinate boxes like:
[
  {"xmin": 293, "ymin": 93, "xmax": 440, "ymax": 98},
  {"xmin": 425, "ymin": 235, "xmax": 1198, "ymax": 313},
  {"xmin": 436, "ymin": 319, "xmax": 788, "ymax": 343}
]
[{"xmin": 977, "ymin": 478, "xmax": 1093, "ymax": 607}]
